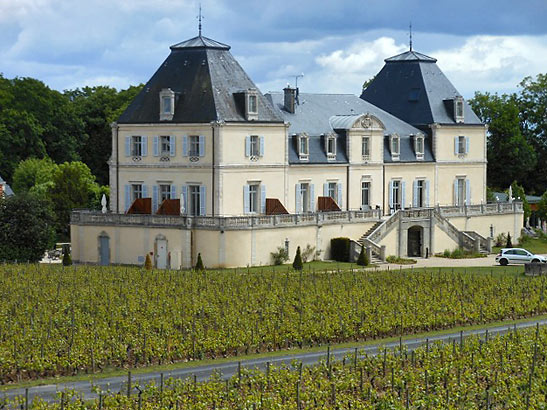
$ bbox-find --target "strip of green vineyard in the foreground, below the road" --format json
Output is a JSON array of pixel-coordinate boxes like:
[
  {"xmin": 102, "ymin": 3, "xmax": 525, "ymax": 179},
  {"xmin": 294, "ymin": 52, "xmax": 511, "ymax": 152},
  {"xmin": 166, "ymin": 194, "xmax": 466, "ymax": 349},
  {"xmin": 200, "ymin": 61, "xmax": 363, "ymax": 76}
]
[{"xmin": 6, "ymin": 328, "xmax": 547, "ymax": 410}]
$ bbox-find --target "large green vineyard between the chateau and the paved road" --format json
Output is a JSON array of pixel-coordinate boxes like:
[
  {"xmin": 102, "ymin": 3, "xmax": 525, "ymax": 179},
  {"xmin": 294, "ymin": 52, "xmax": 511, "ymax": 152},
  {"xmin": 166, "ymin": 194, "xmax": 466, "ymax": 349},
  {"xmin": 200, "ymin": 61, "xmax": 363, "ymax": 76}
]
[{"xmin": 0, "ymin": 265, "xmax": 547, "ymax": 383}]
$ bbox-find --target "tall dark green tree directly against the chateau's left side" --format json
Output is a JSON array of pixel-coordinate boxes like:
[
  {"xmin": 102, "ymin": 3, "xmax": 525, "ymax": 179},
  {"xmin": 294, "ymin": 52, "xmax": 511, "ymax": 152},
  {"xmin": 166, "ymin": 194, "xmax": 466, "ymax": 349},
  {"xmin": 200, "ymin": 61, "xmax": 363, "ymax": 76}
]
[{"xmin": 65, "ymin": 85, "xmax": 142, "ymax": 184}]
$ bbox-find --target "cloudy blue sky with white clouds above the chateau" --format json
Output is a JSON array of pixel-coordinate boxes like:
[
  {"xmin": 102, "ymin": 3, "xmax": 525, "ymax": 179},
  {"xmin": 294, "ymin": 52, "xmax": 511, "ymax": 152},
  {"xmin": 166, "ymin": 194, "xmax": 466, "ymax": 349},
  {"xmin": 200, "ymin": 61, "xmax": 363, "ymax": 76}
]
[{"xmin": 0, "ymin": 0, "xmax": 547, "ymax": 97}]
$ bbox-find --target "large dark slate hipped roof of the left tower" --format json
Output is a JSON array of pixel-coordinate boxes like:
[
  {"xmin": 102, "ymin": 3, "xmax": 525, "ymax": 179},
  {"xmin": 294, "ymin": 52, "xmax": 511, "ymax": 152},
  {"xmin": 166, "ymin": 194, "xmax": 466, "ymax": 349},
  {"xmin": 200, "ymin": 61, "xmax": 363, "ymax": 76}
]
[{"xmin": 118, "ymin": 36, "xmax": 283, "ymax": 124}]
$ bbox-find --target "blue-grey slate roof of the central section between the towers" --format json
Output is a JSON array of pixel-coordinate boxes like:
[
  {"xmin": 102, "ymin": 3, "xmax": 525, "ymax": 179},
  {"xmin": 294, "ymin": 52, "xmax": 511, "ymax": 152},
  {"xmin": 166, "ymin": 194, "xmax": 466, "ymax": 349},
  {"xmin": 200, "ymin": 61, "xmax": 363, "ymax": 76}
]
[{"xmin": 266, "ymin": 92, "xmax": 434, "ymax": 164}]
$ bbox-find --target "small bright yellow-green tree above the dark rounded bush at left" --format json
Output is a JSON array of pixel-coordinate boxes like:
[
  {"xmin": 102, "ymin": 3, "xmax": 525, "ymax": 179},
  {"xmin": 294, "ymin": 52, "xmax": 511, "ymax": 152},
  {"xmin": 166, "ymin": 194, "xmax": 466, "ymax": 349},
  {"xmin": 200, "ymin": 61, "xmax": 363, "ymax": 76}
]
[{"xmin": 12, "ymin": 157, "xmax": 59, "ymax": 192}]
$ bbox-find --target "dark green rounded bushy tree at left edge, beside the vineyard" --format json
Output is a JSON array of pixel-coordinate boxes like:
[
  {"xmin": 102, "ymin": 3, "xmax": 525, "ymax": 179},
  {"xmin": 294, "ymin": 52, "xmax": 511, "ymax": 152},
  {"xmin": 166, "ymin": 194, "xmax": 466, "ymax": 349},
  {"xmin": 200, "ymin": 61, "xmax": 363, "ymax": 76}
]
[{"xmin": 0, "ymin": 193, "xmax": 55, "ymax": 262}]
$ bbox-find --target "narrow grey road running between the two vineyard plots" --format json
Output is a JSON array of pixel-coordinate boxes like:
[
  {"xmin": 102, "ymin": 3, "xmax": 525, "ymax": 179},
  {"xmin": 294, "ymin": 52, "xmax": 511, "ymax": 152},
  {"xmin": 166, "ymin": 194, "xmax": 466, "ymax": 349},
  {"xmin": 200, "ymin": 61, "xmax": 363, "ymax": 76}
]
[{"xmin": 4, "ymin": 319, "xmax": 547, "ymax": 402}]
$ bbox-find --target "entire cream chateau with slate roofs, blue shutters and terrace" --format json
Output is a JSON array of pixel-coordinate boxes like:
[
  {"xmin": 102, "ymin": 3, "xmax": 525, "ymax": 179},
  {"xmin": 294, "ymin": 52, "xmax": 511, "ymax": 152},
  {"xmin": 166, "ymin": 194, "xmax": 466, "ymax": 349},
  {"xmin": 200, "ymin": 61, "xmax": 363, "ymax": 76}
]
[{"xmin": 71, "ymin": 35, "xmax": 523, "ymax": 269}]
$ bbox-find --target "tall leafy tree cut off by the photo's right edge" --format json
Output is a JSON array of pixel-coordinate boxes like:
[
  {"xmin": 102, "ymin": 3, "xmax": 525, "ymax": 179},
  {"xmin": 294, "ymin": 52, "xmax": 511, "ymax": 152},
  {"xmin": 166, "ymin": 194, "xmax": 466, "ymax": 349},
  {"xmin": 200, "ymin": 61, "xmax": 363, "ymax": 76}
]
[{"xmin": 517, "ymin": 74, "xmax": 547, "ymax": 195}]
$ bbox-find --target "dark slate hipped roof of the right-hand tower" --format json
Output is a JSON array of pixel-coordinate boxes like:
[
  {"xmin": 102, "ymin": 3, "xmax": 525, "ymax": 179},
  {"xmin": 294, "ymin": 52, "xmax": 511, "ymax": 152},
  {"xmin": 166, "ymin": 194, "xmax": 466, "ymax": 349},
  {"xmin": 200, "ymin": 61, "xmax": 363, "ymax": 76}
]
[{"xmin": 361, "ymin": 51, "xmax": 482, "ymax": 129}]
